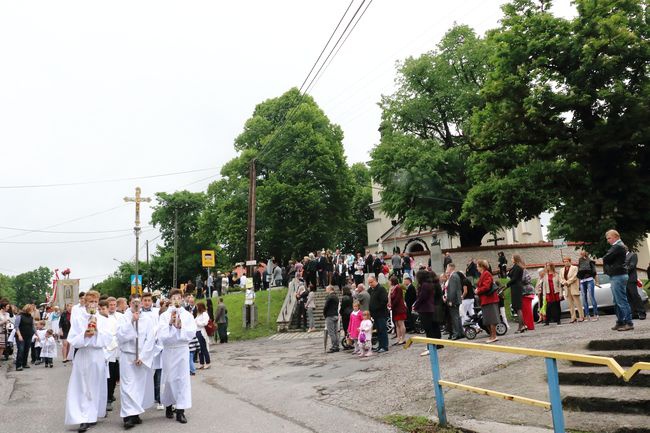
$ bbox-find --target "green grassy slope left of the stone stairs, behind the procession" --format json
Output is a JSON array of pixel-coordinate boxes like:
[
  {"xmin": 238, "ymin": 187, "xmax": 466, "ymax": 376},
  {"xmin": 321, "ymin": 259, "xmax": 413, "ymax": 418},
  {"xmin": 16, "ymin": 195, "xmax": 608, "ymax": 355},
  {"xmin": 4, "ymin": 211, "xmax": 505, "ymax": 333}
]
[{"xmin": 200, "ymin": 287, "xmax": 288, "ymax": 341}]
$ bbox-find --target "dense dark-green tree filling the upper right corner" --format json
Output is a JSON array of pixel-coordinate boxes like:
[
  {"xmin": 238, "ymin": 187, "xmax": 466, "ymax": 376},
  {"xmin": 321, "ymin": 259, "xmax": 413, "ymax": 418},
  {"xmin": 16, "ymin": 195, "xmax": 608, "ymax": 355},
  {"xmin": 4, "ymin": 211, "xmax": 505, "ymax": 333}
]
[{"xmin": 463, "ymin": 0, "xmax": 650, "ymax": 253}]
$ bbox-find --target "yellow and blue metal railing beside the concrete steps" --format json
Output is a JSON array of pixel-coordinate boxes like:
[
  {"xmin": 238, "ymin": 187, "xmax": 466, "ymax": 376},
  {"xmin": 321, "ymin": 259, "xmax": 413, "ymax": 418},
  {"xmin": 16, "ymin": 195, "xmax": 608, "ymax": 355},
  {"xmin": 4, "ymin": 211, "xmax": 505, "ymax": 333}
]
[{"xmin": 404, "ymin": 337, "xmax": 650, "ymax": 433}]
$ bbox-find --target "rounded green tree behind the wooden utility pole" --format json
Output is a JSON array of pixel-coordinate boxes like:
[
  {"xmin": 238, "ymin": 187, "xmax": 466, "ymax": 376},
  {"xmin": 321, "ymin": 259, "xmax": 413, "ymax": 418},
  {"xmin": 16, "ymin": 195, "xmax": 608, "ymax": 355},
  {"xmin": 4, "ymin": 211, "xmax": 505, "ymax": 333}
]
[{"xmin": 202, "ymin": 88, "xmax": 352, "ymax": 261}]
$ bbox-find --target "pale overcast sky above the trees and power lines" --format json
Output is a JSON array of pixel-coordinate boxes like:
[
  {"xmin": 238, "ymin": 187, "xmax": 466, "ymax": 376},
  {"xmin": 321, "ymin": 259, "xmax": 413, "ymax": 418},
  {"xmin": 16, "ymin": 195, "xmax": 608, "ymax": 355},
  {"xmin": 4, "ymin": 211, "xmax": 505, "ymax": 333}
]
[{"xmin": 0, "ymin": 0, "xmax": 573, "ymax": 288}]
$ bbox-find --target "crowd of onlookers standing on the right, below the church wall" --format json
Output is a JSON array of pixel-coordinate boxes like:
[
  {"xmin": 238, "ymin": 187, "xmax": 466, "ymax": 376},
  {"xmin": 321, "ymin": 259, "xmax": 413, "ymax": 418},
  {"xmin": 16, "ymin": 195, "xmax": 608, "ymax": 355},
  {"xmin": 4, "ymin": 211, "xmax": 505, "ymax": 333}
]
[{"xmin": 287, "ymin": 230, "xmax": 646, "ymax": 357}]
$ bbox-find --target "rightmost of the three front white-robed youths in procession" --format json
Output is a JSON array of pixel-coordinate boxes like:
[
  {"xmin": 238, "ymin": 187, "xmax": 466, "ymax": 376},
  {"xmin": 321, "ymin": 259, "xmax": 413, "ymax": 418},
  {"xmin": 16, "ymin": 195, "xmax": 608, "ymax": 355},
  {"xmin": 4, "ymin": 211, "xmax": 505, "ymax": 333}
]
[{"xmin": 158, "ymin": 289, "xmax": 196, "ymax": 424}]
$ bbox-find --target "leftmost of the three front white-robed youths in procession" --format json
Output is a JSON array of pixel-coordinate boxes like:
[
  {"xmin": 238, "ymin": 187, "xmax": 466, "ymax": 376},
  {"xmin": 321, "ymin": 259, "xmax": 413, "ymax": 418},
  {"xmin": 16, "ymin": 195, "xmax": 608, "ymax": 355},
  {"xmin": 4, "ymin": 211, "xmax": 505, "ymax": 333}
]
[{"xmin": 65, "ymin": 290, "xmax": 111, "ymax": 432}]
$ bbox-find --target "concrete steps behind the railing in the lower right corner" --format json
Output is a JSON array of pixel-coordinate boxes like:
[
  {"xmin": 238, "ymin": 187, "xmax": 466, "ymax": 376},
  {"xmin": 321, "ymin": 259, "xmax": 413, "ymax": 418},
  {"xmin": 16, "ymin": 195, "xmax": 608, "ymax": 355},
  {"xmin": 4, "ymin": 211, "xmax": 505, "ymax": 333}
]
[{"xmin": 559, "ymin": 338, "xmax": 650, "ymax": 433}]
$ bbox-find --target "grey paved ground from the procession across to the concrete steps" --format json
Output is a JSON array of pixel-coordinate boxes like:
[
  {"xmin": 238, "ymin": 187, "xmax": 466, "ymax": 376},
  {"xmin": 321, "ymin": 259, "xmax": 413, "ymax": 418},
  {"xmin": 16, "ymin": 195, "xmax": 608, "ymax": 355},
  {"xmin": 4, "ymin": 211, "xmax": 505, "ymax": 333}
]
[{"xmin": 0, "ymin": 316, "xmax": 650, "ymax": 433}]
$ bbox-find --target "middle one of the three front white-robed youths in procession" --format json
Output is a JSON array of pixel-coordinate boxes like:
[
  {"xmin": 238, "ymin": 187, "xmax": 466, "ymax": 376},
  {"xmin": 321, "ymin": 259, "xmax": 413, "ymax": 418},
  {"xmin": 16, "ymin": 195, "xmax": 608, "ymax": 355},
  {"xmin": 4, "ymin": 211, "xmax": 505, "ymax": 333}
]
[{"xmin": 117, "ymin": 295, "xmax": 156, "ymax": 429}]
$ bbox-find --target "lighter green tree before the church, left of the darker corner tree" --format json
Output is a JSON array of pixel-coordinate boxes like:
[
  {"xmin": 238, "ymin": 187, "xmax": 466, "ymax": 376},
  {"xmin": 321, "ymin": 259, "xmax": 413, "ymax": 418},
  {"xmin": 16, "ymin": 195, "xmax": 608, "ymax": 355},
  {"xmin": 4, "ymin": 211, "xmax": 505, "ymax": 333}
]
[{"xmin": 370, "ymin": 26, "xmax": 494, "ymax": 246}]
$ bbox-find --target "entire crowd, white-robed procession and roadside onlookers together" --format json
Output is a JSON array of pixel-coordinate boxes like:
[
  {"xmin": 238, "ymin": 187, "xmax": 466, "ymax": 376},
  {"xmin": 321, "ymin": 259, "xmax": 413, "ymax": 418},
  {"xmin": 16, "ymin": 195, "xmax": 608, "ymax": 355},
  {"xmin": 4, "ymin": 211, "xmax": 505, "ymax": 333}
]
[{"xmin": 0, "ymin": 230, "xmax": 646, "ymax": 432}]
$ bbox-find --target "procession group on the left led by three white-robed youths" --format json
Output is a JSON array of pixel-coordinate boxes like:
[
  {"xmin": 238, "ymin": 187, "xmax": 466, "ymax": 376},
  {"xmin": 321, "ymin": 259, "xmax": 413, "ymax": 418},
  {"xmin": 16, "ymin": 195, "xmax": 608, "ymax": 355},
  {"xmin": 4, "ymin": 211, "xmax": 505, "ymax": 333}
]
[{"xmin": 0, "ymin": 289, "xmax": 228, "ymax": 432}]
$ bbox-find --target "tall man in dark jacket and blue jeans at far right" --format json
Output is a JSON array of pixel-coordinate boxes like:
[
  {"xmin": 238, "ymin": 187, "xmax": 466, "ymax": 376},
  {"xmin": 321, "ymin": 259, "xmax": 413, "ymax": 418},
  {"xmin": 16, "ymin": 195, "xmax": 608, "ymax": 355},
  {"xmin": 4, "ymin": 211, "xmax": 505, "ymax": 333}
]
[{"xmin": 603, "ymin": 230, "xmax": 634, "ymax": 331}]
